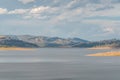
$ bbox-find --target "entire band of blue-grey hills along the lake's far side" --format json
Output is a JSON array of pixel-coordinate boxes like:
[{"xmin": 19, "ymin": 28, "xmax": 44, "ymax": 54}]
[{"xmin": 0, "ymin": 35, "xmax": 120, "ymax": 48}]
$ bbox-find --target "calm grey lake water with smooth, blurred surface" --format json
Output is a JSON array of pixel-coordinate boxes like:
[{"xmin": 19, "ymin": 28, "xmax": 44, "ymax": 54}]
[{"xmin": 0, "ymin": 48, "xmax": 120, "ymax": 80}]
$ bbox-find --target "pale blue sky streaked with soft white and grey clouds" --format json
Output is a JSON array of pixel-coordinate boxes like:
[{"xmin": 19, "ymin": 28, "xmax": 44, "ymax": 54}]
[{"xmin": 0, "ymin": 0, "xmax": 120, "ymax": 40}]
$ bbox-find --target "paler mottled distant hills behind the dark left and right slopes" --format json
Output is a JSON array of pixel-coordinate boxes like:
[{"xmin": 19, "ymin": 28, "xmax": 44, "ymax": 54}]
[{"xmin": 3, "ymin": 35, "xmax": 88, "ymax": 47}]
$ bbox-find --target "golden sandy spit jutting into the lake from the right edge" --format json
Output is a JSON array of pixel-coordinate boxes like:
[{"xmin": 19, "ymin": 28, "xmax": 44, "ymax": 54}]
[{"xmin": 86, "ymin": 52, "xmax": 120, "ymax": 56}]
